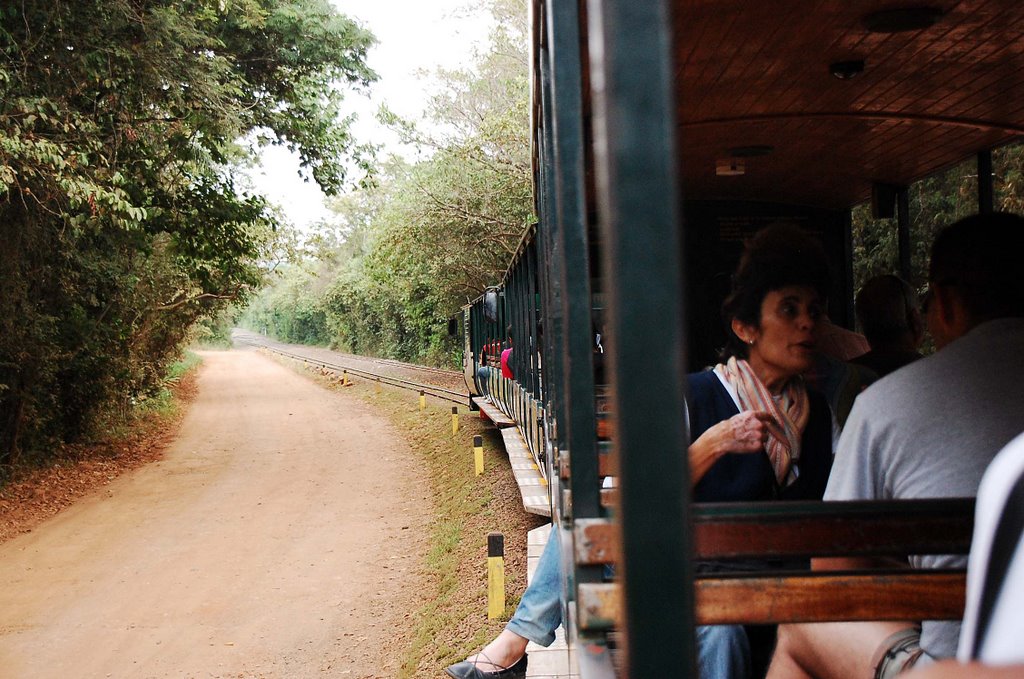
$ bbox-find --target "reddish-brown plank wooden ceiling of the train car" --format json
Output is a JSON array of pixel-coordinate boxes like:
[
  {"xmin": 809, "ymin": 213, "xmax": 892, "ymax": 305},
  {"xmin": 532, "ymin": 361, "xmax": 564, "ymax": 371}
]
[{"xmin": 673, "ymin": 0, "xmax": 1024, "ymax": 208}]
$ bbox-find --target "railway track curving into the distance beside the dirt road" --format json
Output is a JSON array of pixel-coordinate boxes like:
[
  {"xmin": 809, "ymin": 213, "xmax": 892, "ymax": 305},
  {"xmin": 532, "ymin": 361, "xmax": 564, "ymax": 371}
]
[{"xmin": 231, "ymin": 330, "xmax": 471, "ymax": 407}]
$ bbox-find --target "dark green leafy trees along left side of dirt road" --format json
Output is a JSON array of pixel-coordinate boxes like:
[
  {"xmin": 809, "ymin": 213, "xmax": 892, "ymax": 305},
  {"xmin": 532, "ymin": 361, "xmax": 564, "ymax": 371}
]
[{"xmin": 0, "ymin": 0, "xmax": 375, "ymax": 464}]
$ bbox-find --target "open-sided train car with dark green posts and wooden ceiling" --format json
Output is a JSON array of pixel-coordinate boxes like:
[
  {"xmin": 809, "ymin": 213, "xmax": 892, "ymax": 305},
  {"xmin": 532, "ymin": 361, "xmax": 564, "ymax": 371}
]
[{"xmin": 465, "ymin": 0, "xmax": 1024, "ymax": 677}]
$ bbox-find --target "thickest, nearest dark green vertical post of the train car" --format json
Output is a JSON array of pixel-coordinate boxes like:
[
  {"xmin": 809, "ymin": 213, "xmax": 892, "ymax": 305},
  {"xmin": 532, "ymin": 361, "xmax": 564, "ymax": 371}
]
[{"xmin": 587, "ymin": 0, "xmax": 695, "ymax": 678}]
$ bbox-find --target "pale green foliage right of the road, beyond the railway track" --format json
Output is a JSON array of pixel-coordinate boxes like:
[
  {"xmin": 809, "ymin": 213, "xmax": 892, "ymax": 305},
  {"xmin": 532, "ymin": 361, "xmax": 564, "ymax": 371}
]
[{"xmin": 246, "ymin": 0, "xmax": 532, "ymax": 365}]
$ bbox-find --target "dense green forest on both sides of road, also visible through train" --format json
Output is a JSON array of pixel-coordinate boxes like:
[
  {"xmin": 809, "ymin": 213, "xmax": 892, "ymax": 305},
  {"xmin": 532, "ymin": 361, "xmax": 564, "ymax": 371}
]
[{"xmin": 0, "ymin": 0, "xmax": 1024, "ymax": 482}]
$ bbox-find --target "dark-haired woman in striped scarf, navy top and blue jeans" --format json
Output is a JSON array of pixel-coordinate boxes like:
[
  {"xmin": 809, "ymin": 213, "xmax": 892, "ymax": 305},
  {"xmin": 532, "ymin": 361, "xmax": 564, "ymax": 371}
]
[{"xmin": 446, "ymin": 226, "xmax": 833, "ymax": 679}]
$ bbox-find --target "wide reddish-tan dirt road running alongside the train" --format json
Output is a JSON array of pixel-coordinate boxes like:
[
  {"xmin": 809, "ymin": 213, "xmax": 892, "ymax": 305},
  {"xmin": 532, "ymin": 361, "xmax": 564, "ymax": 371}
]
[{"xmin": 0, "ymin": 350, "xmax": 430, "ymax": 679}]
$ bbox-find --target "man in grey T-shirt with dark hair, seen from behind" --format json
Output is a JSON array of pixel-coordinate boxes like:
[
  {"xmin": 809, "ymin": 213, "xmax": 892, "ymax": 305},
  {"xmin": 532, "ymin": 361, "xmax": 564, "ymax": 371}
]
[{"xmin": 768, "ymin": 214, "xmax": 1024, "ymax": 679}]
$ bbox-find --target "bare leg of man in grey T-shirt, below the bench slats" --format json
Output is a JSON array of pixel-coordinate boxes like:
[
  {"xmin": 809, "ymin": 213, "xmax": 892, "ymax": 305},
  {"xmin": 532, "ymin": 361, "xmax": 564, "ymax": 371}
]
[{"xmin": 766, "ymin": 622, "xmax": 910, "ymax": 679}]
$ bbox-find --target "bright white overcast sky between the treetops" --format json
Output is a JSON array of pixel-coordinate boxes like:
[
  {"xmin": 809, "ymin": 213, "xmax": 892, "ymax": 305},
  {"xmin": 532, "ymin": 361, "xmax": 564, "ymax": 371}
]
[{"xmin": 243, "ymin": 0, "xmax": 487, "ymax": 227}]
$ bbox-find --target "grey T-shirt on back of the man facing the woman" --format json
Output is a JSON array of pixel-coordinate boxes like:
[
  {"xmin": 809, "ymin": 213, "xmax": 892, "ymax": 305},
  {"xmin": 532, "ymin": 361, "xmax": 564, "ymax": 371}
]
[{"xmin": 831, "ymin": 324, "xmax": 1024, "ymax": 499}]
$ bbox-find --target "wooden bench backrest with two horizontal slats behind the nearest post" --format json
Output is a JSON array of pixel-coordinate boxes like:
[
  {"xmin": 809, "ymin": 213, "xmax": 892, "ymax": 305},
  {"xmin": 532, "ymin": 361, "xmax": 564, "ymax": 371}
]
[{"xmin": 574, "ymin": 499, "xmax": 974, "ymax": 633}]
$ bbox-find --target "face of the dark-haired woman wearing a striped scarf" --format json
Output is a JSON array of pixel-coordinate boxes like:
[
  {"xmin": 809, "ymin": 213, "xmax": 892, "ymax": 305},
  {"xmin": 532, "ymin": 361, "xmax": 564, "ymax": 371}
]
[{"xmin": 733, "ymin": 286, "xmax": 822, "ymax": 389}]
